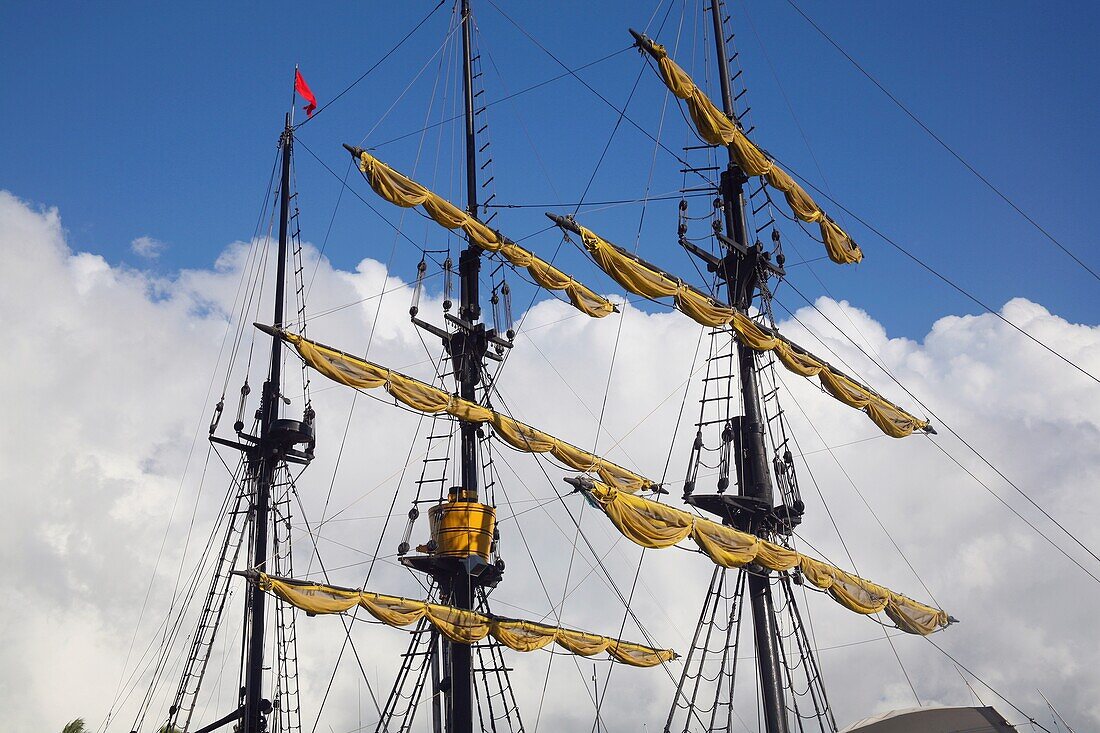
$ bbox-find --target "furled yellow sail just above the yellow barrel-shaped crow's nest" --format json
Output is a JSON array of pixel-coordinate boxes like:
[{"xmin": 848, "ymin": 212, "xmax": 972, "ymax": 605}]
[{"xmin": 275, "ymin": 327, "xmax": 653, "ymax": 492}]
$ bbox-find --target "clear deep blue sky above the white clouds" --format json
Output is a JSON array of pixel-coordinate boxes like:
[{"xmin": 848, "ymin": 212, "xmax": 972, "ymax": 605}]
[{"xmin": 0, "ymin": 0, "xmax": 1100, "ymax": 337}]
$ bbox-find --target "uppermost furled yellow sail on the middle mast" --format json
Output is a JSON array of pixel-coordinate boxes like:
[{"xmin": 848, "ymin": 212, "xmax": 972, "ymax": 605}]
[{"xmin": 353, "ymin": 151, "xmax": 615, "ymax": 318}]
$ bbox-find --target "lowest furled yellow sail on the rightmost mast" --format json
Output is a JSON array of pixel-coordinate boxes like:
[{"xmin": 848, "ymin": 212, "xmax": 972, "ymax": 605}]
[{"xmin": 585, "ymin": 482, "xmax": 949, "ymax": 635}]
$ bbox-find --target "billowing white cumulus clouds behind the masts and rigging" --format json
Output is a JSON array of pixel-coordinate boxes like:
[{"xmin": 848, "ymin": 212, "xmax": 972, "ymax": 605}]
[{"xmin": 0, "ymin": 193, "xmax": 1100, "ymax": 733}]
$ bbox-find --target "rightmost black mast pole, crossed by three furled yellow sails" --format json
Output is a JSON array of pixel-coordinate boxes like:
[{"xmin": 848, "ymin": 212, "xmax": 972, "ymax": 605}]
[{"xmin": 711, "ymin": 5, "xmax": 788, "ymax": 733}]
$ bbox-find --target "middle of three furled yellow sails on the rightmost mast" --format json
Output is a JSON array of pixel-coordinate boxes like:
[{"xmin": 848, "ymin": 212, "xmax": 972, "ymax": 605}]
[{"xmin": 558, "ymin": 221, "xmax": 928, "ymax": 438}]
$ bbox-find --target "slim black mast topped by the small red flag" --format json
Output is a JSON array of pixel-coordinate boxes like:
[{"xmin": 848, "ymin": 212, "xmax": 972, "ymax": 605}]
[{"xmin": 243, "ymin": 112, "xmax": 294, "ymax": 733}]
